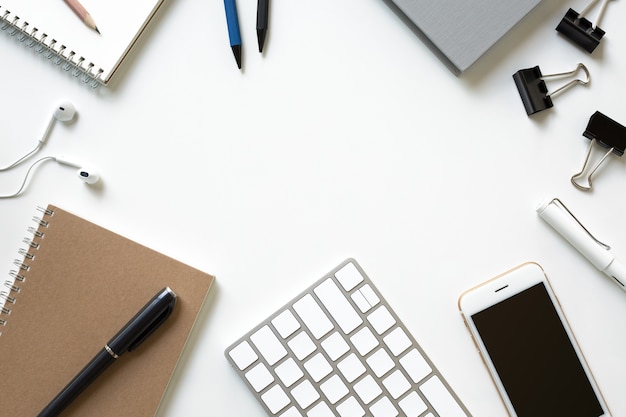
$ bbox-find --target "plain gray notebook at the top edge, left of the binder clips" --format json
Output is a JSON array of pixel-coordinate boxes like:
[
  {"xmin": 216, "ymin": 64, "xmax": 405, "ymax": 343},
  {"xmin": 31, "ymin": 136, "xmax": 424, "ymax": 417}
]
[{"xmin": 385, "ymin": 0, "xmax": 541, "ymax": 74}]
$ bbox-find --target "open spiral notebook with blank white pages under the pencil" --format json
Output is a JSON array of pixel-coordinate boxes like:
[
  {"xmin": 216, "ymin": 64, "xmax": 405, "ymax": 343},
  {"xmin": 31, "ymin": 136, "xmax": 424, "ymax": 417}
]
[{"xmin": 0, "ymin": 0, "xmax": 164, "ymax": 87}]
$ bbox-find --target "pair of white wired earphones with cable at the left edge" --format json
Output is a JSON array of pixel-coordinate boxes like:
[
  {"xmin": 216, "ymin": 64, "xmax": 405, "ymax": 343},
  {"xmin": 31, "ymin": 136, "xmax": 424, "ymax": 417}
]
[{"xmin": 0, "ymin": 101, "xmax": 100, "ymax": 199}]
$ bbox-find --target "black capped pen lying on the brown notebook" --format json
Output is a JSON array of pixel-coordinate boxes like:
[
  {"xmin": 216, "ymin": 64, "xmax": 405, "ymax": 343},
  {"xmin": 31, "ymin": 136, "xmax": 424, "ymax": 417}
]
[{"xmin": 38, "ymin": 287, "xmax": 176, "ymax": 417}]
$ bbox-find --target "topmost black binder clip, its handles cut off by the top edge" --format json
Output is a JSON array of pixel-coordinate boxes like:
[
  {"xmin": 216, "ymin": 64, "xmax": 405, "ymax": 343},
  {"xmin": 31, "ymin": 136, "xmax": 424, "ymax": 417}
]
[{"xmin": 556, "ymin": 0, "xmax": 611, "ymax": 53}]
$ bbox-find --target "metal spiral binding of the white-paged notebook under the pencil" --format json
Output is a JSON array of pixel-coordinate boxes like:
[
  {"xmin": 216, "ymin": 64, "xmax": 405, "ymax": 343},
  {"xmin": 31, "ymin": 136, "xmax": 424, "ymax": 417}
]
[{"xmin": 0, "ymin": 6, "xmax": 104, "ymax": 88}]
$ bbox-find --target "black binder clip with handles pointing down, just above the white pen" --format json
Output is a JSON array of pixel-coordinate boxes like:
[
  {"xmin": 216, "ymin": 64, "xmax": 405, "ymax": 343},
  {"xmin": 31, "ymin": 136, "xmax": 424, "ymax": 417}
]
[{"xmin": 571, "ymin": 111, "xmax": 626, "ymax": 191}]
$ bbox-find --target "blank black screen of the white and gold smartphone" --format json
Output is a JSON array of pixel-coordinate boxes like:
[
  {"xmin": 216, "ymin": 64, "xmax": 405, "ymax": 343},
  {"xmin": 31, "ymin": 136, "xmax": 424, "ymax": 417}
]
[{"xmin": 472, "ymin": 283, "xmax": 604, "ymax": 417}]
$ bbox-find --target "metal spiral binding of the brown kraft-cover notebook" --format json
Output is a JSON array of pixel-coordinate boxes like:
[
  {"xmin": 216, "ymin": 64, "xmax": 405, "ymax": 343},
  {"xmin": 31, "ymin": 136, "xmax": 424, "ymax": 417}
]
[{"xmin": 0, "ymin": 207, "xmax": 54, "ymax": 336}]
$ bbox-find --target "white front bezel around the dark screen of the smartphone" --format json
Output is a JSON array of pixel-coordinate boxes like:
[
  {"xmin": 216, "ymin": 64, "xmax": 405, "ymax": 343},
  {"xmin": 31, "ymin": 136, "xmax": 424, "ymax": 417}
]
[{"xmin": 458, "ymin": 262, "xmax": 611, "ymax": 417}]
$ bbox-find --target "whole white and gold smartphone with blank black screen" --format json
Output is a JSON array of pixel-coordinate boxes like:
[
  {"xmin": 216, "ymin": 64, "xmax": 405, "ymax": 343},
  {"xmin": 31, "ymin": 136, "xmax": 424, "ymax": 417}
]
[{"xmin": 459, "ymin": 262, "xmax": 611, "ymax": 417}]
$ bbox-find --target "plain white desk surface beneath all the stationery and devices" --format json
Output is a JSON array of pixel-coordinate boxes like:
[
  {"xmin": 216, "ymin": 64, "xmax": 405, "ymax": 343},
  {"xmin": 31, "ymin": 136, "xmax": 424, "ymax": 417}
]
[{"xmin": 0, "ymin": 0, "xmax": 626, "ymax": 417}]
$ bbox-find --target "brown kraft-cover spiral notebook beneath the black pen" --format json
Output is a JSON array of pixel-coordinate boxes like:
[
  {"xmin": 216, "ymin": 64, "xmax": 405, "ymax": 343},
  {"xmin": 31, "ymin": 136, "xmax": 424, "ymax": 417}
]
[{"xmin": 0, "ymin": 205, "xmax": 214, "ymax": 417}]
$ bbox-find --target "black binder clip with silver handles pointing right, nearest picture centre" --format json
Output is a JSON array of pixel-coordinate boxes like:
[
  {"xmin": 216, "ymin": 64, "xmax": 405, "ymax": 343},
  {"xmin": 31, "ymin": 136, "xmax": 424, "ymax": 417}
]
[{"xmin": 513, "ymin": 64, "xmax": 591, "ymax": 116}]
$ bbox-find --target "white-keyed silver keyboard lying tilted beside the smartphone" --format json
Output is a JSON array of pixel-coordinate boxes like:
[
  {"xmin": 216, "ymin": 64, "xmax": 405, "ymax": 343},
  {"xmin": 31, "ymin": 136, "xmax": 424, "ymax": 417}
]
[{"xmin": 226, "ymin": 259, "xmax": 470, "ymax": 417}]
